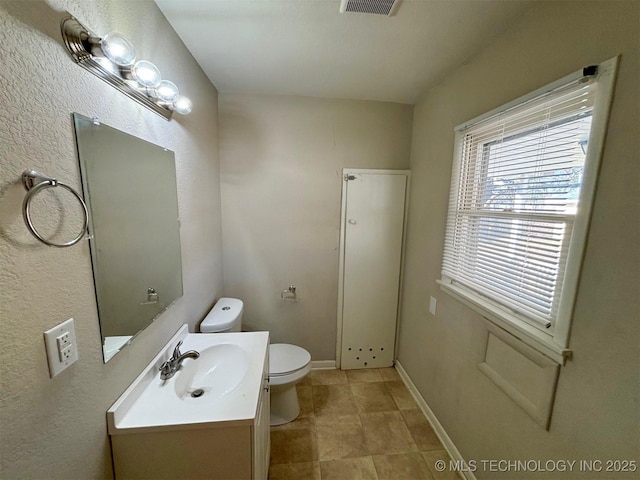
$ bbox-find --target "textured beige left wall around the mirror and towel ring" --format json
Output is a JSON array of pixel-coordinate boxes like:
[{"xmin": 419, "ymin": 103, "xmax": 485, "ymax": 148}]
[{"xmin": 0, "ymin": 0, "xmax": 222, "ymax": 480}]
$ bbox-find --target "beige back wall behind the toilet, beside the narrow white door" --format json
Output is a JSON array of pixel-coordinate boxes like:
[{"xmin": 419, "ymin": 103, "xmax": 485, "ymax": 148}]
[{"xmin": 220, "ymin": 94, "xmax": 413, "ymax": 360}]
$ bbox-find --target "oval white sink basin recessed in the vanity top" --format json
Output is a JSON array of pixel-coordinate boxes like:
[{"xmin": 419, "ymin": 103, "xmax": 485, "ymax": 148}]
[{"xmin": 173, "ymin": 343, "xmax": 249, "ymax": 402}]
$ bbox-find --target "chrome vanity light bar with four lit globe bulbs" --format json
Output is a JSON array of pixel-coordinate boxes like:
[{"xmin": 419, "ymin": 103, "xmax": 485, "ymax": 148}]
[{"xmin": 61, "ymin": 15, "xmax": 193, "ymax": 120}]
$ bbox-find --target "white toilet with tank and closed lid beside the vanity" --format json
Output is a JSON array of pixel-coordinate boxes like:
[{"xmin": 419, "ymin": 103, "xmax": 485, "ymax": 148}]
[{"xmin": 200, "ymin": 297, "xmax": 311, "ymax": 426}]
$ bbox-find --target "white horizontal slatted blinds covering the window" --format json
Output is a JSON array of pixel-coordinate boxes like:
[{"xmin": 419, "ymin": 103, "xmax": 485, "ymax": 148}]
[{"xmin": 442, "ymin": 77, "xmax": 596, "ymax": 331}]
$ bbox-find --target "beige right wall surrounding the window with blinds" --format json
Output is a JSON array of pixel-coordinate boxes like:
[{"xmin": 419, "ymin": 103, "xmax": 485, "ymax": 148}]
[{"xmin": 400, "ymin": 1, "xmax": 640, "ymax": 479}]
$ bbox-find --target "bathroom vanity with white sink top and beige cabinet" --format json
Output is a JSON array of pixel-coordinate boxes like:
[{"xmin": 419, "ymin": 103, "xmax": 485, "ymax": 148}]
[{"xmin": 107, "ymin": 325, "xmax": 270, "ymax": 480}]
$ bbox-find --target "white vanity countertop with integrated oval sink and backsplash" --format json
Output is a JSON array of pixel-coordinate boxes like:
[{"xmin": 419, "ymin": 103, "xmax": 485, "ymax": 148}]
[{"xmin": 107, "ymin": 325, "xmax": 269, "ymax": 435}]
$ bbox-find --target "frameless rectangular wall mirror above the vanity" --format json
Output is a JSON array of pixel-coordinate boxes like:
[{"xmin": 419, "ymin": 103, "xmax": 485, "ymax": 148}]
[{"xmin": 73, "ymin": 113, "xmax": 182, "ymax": 363}]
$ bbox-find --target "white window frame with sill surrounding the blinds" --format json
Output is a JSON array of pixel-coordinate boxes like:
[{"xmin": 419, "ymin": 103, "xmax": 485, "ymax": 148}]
[{"xmin": 436, "ymin": 57, "xmax": 619, "ymax": 364}]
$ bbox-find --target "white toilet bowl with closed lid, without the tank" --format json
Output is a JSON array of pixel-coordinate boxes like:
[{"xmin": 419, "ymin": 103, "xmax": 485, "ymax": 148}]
[{"xmin": 269, "ymin": 343, "xmax": 311, "ymax": 426}]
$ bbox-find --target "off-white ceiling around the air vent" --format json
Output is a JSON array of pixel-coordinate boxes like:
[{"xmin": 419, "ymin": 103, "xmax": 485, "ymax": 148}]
[{"xmin": 155, "ymin": 0, "xmax": 533, "ymax": 104}]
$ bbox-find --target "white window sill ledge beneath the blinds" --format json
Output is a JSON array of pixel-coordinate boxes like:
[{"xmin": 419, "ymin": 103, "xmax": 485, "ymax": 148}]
[{"xmin": 436, "ymin": 280, "xmax": 571, "ymax": 365}]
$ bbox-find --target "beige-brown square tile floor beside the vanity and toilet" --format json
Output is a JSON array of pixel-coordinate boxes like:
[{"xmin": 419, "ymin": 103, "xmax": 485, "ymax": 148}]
[{"xmin": 269, "ymin": 367, "xmax": 459, "ymax": 480}]
